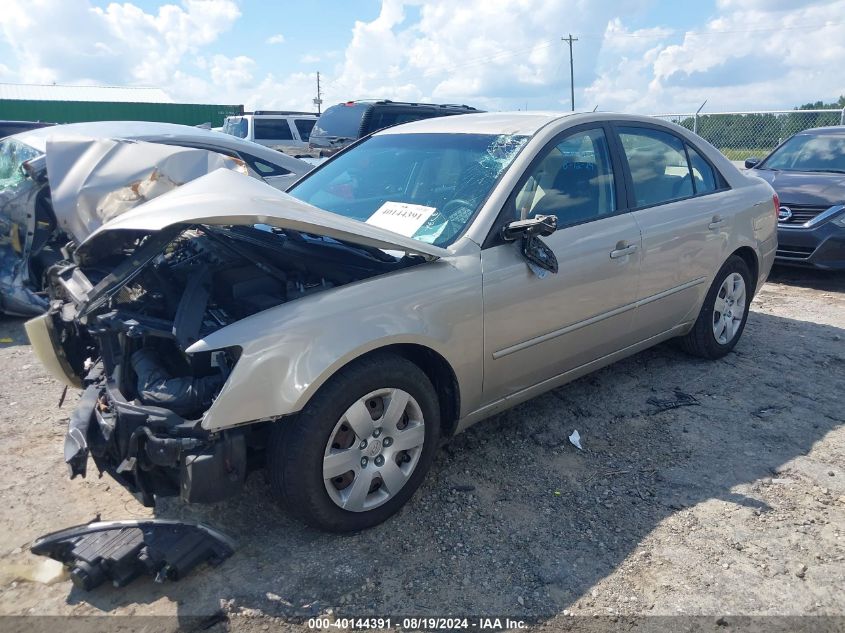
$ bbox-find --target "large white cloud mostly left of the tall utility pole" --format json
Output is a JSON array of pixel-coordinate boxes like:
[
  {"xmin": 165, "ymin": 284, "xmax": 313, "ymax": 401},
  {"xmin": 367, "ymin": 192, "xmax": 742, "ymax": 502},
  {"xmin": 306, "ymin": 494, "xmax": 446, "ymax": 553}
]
[{"xmin": 314, "ymin": 0, "xmax": 648, "ymax": 109}]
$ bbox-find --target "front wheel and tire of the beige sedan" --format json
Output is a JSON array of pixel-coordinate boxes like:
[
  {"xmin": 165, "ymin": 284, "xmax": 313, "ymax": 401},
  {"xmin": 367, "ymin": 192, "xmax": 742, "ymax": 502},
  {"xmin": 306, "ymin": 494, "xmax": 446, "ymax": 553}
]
[{"xmin": 267, "ymin": 353, "xmax": 440, "ymax": 532}]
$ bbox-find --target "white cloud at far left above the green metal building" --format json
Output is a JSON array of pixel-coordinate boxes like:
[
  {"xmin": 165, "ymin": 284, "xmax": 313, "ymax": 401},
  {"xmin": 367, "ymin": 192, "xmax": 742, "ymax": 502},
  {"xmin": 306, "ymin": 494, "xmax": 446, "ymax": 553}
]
[{"xmin": 0, "ymin": 0, "xmax": 240, "ymax": 98}]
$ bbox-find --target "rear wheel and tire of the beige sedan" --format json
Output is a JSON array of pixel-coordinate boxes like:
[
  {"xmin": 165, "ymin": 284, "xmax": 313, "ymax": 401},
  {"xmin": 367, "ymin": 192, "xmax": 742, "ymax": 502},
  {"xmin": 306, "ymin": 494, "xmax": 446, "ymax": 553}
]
[{"xmin": 680, "ymin": 255, "xmax": 753, "ymax": 360}]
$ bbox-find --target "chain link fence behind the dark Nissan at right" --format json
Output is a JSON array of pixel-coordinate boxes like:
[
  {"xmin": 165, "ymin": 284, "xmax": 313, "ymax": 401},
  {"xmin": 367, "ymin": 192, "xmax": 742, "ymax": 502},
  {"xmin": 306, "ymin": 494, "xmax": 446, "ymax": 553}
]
[{"xmin": 654, "ymin": 108, "xmax": 845, "ymax": 161}]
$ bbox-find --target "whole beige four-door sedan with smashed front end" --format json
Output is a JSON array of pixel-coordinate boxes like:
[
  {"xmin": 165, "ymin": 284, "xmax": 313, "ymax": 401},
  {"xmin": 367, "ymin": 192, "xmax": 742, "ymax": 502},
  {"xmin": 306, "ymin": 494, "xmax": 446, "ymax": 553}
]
[{"xmin": 27, "ymin": 113, "xmax": 777, "ymax": 531}]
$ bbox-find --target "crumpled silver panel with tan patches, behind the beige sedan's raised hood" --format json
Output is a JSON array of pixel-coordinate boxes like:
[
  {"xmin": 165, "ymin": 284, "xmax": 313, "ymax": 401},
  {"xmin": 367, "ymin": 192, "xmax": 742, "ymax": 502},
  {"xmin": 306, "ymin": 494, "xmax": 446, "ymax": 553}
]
[{"xmin": 46, "ymin": 136, "xmax": 247, "ymax": 243}]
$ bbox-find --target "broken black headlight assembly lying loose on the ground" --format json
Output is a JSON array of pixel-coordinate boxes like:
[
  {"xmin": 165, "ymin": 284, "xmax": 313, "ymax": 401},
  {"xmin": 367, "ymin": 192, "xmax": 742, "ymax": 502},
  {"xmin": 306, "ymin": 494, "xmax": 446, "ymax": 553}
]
[{"xmin": 30, "ymin": 519, "xmax": 235, "ymax": 591}]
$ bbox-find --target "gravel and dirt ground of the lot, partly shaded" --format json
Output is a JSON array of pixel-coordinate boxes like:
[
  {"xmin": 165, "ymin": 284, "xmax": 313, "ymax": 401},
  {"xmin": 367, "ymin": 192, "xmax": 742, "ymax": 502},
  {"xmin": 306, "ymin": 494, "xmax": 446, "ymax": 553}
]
[{"xmin": 0, "ymin": 264, "xmax": 845, "ymax": 630}]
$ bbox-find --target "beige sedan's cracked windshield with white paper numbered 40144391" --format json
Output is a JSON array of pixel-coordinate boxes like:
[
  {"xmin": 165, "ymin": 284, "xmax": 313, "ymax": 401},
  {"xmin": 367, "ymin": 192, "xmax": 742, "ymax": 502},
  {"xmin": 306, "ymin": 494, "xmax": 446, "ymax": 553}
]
[{"xmin": 290, "ymin": 134, "xmax": 528, "ymax": 246}]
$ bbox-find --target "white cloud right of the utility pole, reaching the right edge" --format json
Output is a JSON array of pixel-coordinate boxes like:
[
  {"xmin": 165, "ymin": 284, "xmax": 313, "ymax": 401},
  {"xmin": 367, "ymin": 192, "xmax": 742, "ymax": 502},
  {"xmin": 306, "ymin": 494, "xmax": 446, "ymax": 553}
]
[{"xmin": 585, "ymin": 0, "xmax": 845, "ymax": 113}]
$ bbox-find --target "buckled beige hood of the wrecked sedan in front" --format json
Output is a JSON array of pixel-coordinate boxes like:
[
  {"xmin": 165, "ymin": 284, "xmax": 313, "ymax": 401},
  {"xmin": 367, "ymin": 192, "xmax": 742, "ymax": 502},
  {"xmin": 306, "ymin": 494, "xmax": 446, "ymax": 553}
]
[{"xmin": 78, "ymin": 169, "xmax": 450, "ymax": 258}]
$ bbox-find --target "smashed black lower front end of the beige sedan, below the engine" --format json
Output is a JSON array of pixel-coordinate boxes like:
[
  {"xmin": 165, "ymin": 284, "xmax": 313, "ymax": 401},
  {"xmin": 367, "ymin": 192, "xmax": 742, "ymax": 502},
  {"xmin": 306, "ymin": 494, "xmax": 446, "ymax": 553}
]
[{"xmin": 65, "ymin": 350, "xmax": 251, "ymax": 506}]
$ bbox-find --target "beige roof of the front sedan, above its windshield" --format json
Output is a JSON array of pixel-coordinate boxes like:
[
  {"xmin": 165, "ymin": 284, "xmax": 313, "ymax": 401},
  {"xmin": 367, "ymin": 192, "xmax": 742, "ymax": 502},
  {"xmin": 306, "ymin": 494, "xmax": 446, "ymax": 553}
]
[{"xmin": 375, "ymin": 112, "xmax": 575, "ymax": 136}]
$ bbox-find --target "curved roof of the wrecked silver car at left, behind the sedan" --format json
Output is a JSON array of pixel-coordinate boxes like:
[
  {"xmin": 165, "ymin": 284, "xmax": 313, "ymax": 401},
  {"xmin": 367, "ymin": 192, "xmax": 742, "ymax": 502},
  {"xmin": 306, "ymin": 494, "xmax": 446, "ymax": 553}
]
[{"xmin": 9, "ymin": 121, "xmax": 310, "ymax": 173}]
